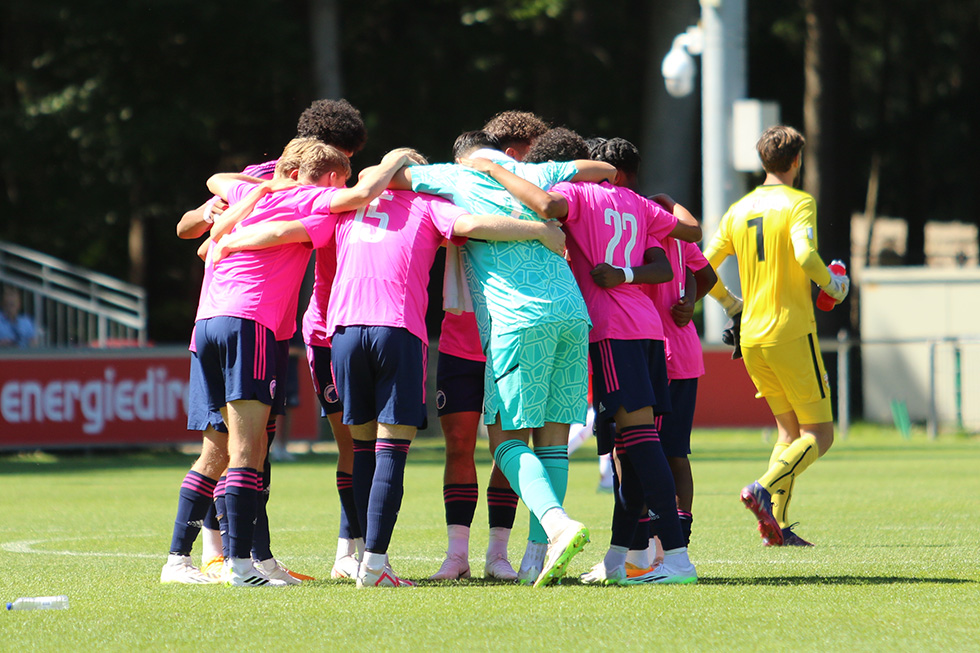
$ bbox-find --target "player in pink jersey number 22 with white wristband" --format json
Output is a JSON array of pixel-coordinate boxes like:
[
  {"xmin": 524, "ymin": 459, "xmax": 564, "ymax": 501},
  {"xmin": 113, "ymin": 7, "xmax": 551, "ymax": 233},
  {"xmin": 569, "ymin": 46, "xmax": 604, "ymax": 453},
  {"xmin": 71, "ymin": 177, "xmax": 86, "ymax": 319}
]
[{"xmin": 473, "ymin": 130, "xmax": 701, "ymax": 583}]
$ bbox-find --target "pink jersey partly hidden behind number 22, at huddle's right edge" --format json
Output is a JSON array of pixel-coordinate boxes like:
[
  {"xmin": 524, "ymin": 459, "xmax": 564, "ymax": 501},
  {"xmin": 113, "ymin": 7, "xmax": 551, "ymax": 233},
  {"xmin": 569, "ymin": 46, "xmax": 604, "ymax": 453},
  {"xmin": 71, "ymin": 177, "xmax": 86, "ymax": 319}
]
[{"xmin": 643, "ymin": 237, "xmax": 708, "ymax": 379}]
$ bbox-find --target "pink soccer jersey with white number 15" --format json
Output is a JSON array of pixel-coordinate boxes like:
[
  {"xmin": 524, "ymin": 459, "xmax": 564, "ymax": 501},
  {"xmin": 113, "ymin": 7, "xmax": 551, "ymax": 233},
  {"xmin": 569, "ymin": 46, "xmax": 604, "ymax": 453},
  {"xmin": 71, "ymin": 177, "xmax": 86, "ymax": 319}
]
[{"xmin": 327, "ymin": 191, "xmax": 466, "ymax": 344}]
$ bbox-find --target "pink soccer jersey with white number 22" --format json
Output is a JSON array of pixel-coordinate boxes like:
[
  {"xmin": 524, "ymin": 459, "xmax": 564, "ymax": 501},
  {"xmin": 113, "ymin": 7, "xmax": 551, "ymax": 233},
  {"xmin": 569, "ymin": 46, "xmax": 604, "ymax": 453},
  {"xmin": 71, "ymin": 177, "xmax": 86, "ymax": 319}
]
[{"xmin": 551, "ymin": 182, "xmax": 677, "ymax": 342}]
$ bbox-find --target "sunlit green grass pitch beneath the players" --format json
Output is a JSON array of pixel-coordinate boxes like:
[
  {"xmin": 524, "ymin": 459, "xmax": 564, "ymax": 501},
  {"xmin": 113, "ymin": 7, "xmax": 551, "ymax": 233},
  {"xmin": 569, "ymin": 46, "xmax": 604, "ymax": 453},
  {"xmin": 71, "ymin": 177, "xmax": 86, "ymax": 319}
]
[{"xmin": 0, "ymin": 426, "xmax": 980, "ymax": 652}]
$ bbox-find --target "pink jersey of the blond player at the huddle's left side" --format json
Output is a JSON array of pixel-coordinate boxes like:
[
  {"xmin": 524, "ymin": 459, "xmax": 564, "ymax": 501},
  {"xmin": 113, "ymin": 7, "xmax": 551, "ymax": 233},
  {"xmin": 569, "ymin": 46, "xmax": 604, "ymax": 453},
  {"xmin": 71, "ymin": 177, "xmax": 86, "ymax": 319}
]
[{"xmin": 196, "ymin": 182, "xmax": 337, "ymax": 340}]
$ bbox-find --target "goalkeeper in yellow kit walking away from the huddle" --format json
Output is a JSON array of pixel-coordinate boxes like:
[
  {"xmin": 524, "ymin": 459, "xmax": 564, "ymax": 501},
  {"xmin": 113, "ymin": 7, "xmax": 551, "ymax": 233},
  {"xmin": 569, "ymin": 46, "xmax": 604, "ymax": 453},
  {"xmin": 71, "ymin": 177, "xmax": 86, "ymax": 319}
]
[{"xmin": 704, "ymin": 125, "xmax": 850, "ymax": 546}]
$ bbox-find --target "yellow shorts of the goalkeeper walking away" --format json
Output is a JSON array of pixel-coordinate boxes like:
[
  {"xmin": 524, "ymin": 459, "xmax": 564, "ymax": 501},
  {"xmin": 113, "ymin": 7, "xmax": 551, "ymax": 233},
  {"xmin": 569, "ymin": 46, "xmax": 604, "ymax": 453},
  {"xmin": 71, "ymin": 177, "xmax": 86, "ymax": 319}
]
[{"xmin": 742, "ymin": 333, "xmax": 833, "ymax": 424}]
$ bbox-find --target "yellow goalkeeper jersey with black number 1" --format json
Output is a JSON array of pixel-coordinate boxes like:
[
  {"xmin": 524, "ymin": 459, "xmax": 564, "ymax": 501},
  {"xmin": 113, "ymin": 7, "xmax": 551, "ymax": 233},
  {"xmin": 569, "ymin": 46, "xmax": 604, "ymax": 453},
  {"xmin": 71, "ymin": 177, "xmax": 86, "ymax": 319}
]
[{"xmin": 704, "ymin": 185, "xmax": 829, "ymax": 346}]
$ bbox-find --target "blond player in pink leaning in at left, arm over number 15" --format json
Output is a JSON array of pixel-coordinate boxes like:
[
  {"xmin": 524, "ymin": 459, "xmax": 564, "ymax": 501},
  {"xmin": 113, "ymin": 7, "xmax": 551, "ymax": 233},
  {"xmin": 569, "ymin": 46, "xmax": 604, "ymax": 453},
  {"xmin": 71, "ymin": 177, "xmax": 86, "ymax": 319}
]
[{"xmin": 192, "ymin": 143, "xmax": 405, "ymax": 586}]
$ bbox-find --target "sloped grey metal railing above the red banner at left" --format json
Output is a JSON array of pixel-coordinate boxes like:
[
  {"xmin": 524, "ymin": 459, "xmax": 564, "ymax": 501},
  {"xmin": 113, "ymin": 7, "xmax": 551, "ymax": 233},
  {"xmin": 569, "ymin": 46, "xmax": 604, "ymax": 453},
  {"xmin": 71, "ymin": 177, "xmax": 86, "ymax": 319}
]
[{"xmin": 0, "ymin": 241, "xmax": 147, "ymax": 347}]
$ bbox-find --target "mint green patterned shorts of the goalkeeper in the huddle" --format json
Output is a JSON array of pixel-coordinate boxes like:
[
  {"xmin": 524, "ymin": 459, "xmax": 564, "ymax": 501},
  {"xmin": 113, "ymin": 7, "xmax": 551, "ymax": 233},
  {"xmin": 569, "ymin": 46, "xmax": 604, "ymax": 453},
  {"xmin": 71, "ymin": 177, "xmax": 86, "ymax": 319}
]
[{"xmin": 483, "ymin": 320, "xmax": 589, "ymax": 431}]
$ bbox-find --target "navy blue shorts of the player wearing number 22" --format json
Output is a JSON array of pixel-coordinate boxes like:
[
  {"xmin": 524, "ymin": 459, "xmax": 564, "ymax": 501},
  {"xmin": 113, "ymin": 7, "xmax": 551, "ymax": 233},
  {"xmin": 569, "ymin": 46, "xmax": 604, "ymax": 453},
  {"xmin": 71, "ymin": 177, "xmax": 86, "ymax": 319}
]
[{"xmin": 589, "ymin": 340, "xmax": 670, "ymax": 420}]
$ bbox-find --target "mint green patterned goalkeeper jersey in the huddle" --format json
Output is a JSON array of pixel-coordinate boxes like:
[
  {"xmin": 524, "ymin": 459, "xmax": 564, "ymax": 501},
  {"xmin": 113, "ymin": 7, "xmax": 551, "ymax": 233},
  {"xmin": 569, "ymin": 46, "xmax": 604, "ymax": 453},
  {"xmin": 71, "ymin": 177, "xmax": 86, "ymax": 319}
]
[{"xmin": 412, "ymin": 150, "xmax": 591, "ymax": 338}]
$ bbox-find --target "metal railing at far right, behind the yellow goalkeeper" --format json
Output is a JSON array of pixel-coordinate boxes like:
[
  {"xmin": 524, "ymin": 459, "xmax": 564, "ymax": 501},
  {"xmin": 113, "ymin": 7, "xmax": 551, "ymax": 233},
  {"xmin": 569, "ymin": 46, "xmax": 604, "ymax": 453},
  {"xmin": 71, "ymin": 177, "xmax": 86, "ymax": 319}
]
[{"xmin": 837, "ymin": 329, "xmax": 980, "ymax": 440}]
